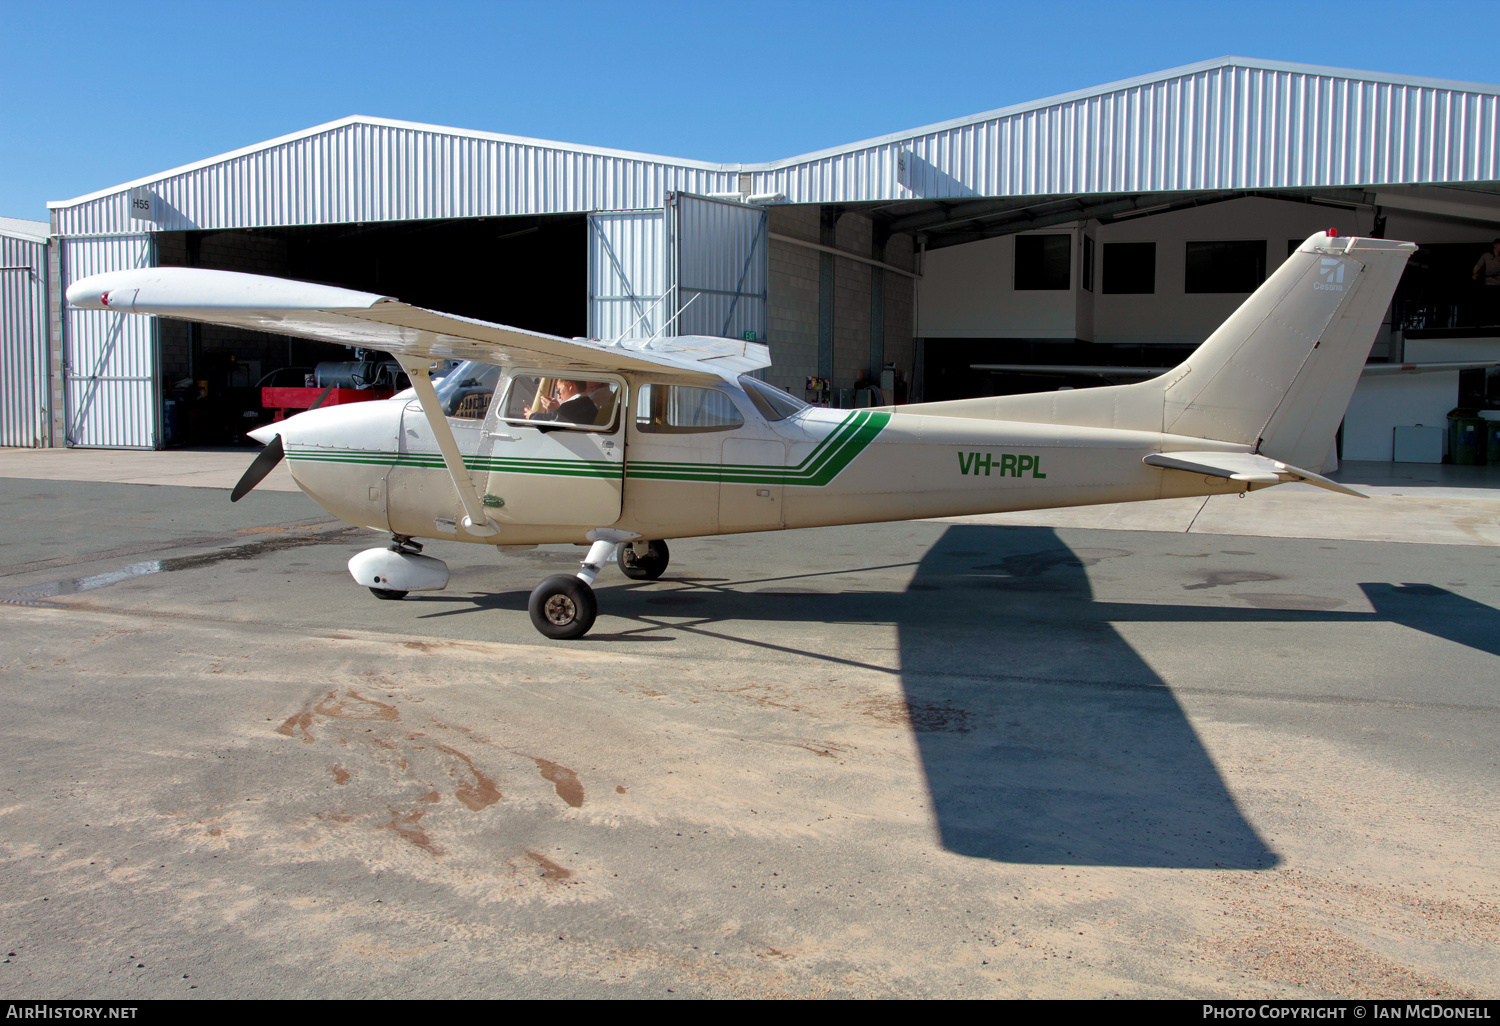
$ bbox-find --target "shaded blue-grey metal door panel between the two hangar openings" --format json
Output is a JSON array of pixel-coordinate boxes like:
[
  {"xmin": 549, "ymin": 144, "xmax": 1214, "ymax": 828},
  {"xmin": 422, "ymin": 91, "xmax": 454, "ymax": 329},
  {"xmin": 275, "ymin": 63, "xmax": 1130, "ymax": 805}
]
[{"xmin": 668, "ymin": 194, "xmax": 770, "ymax": 341}]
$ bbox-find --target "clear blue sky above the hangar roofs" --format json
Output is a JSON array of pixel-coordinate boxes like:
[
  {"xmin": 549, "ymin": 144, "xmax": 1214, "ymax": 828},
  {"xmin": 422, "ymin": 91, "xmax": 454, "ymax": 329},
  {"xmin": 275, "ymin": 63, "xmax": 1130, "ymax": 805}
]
[{"xmin": 0, "ymin": 0, "xmax": 1500, "ymax": 221}]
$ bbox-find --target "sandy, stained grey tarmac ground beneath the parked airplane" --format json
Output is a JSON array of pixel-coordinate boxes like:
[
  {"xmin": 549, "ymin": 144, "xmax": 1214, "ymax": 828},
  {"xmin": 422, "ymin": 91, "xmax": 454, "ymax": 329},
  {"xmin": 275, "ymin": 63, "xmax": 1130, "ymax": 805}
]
[{"xmin": 0, "ymin": 450, "xmax": 1500, "ymax": 998}]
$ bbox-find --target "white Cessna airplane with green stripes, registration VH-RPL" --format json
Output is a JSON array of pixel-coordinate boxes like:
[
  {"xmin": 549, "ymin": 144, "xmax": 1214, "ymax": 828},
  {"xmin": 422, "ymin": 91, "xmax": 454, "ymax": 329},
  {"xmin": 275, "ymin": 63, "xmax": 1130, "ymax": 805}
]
[{"xmin": 68, "ymin": 231, "xmax": 1416, "ymax": 639}]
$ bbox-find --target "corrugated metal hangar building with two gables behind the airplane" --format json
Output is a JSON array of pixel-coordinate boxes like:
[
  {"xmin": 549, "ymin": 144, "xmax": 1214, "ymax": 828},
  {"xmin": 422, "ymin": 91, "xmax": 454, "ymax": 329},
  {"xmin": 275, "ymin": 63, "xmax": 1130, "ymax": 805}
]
[{"xmin": 20, "ymin": 57, "xmax": 1500, "ymax": 459}]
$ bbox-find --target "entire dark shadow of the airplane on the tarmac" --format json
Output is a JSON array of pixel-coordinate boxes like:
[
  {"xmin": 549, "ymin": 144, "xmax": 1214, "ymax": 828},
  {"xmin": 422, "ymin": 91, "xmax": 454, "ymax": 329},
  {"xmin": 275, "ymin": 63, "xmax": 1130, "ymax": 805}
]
[{"xmin": 408, "ymin": 525, "xmax": 1500, "ymax": 870}]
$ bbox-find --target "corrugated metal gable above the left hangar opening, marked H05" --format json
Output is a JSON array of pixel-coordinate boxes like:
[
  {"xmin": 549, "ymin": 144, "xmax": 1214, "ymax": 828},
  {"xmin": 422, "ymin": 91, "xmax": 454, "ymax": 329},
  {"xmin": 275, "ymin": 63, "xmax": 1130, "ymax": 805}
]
[{"xmin": 56, "ymin": 122, "xmax": 738, "ymax": 236}]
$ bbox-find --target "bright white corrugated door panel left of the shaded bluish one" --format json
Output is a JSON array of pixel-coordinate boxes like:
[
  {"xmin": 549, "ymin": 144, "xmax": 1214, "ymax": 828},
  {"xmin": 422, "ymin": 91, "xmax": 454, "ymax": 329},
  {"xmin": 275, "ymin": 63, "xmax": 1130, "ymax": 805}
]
[{"xmin": 588, "ymin": 210, "xmax": 669, "ymax": 339}]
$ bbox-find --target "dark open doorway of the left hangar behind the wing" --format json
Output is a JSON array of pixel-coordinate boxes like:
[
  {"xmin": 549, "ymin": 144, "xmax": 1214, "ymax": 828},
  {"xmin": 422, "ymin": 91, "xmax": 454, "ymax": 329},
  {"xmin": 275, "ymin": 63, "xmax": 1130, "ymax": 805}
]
[{"xmin": 156, "ymin": 215, "xmax": 588, "ymax": 446}]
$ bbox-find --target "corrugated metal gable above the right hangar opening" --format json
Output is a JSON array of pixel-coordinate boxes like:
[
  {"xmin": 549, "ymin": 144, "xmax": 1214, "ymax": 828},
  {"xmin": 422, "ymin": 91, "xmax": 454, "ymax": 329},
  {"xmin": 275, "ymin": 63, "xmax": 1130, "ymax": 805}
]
[{"xmin": 753, "ymin": 66, "xmax": 1500, "ymax": 203}]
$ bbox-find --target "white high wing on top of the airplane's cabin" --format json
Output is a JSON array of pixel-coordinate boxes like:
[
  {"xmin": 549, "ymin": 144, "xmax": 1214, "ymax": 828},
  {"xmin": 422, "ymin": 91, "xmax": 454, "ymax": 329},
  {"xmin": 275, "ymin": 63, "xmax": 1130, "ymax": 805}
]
[{"xmin": 68, "ymin": 267, "xmax": 771, "ymax": 380}]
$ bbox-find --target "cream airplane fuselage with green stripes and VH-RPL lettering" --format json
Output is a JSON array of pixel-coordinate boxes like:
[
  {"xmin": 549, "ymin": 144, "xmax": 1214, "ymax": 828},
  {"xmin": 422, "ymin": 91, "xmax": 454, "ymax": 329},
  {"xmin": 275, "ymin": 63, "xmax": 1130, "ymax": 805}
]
[{"xmin": 279, "ymin": 375, "xmax": 1248, "ymax": 546}]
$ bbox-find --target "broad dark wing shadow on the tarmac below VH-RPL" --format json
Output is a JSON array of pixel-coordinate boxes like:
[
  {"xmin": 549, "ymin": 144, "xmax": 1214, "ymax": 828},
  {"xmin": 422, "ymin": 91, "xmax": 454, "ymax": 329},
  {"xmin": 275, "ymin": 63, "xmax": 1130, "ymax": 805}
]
[{"xmin": 899, "ymin": 525, "xmax": 1278, "ymax": 869}]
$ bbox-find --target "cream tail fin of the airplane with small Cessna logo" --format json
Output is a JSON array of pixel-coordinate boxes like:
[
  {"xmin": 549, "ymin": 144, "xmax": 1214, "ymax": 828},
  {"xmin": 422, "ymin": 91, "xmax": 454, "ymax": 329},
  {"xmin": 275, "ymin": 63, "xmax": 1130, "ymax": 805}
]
[{"xmin": 902, "ymin": 233, "xmax": 1416, "ymax": 468}]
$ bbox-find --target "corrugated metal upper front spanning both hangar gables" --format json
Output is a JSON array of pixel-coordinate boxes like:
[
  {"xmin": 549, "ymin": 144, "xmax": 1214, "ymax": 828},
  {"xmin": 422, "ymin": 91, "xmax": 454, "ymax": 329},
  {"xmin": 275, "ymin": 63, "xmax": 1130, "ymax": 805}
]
[{"xmin": 48, "ymin": 57, "xmax": 1500, "ymax": 236}]
